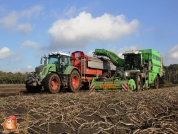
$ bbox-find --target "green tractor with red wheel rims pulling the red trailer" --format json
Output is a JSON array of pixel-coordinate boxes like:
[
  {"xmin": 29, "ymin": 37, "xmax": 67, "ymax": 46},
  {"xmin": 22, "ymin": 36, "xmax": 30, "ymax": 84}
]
[{"xmin": 25, "ymin": 52, "xmax": 81, "ymax": 93}]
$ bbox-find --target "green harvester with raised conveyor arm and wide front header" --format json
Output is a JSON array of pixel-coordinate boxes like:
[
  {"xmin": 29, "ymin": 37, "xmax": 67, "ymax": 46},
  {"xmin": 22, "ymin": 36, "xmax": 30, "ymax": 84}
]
[{"xmin": 90, "ymin": 49, "xmax": 164, "ymax": 91}]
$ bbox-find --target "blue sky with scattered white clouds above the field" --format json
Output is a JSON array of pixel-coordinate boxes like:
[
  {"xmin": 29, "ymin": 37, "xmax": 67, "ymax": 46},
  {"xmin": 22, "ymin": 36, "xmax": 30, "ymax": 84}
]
[{"xmin": 0, "ymin": 0, "xmax": 178, "ymax": 73}]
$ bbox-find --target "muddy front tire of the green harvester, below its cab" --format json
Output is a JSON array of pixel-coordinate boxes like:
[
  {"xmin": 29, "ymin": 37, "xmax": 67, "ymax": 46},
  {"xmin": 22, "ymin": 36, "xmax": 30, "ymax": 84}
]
[{"xmin": 135, "ymin": 72, "xmax": 143, "ymax": 91}]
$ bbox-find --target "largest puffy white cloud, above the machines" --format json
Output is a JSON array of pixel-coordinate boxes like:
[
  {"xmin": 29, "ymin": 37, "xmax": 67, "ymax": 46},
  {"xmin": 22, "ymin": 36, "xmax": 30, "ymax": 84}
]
[{"xmin": 48, "ymin": 12, "xmax": 139, "ymax": 49}]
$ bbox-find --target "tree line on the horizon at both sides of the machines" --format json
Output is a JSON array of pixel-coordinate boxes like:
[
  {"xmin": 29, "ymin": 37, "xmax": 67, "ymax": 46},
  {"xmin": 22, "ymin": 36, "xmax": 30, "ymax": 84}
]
[{"xmin": 0, "ymin": 64, "xmax": 178, "ymax": 84}]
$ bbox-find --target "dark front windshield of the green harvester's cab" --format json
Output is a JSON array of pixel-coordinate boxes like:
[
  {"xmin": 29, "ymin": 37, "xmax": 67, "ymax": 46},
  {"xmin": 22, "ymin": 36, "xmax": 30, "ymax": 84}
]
[{"xmin": 124, "ymin": 54, "xmax": 141, "ymax": 70}]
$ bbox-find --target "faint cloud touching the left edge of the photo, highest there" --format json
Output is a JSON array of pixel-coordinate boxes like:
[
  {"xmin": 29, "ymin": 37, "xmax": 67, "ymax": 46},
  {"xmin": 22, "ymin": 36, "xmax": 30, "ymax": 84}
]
[{"xmin": 0, "ymin": 11, "xmax": 18, "ymax": 30}]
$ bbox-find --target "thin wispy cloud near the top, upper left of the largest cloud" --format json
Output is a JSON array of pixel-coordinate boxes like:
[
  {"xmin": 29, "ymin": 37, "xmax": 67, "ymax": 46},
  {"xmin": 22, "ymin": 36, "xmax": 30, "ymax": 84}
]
[{"xmin": 21, "ymin": 5, "xmax": 43, "ymax": 19}]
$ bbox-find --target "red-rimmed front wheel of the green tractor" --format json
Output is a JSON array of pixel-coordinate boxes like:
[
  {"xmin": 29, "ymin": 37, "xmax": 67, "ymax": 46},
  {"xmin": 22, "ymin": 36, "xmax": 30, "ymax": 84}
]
[{"xmin": 44, "ymin": 73, "xmax": 61, "ymax": 94}]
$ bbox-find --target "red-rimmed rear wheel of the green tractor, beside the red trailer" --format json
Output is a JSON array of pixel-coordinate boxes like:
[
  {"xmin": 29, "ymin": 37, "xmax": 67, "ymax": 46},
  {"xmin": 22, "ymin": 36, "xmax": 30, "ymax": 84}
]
[{"xmin": 69, "ymin": 70, "xmax": 81, "ymax": 92}]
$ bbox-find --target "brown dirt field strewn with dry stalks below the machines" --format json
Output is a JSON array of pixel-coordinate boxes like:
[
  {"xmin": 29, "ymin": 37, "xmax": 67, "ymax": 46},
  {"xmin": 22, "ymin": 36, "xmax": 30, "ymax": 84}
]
[{"xmin": 0, "ymin": 85, "xmax": 178, "ymax": 134}]
